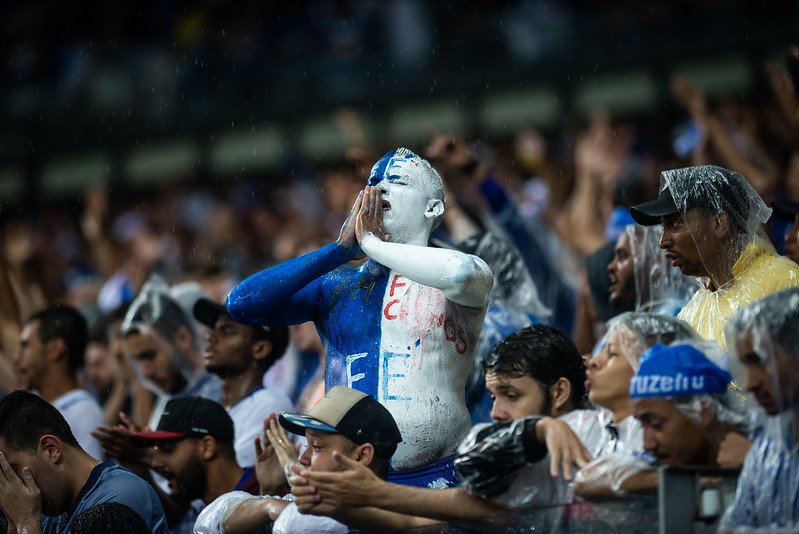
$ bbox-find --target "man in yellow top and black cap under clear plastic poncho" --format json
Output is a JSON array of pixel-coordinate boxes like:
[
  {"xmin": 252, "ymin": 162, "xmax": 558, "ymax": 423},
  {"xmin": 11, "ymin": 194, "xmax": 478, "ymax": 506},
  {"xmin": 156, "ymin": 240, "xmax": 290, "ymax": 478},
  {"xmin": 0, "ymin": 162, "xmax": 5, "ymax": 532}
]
[{"xmin": 631, "ymin": 165, "xmax": 799, "ymax": 348}]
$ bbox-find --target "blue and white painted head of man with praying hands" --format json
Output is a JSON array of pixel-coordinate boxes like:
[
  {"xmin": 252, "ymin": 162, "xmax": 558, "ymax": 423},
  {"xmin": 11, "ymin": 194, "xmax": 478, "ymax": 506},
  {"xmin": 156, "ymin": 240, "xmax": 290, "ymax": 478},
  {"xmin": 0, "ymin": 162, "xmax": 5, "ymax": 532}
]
[{"xmin": 367, "ymin": 148, "xmax": 444, "ymax": 244}]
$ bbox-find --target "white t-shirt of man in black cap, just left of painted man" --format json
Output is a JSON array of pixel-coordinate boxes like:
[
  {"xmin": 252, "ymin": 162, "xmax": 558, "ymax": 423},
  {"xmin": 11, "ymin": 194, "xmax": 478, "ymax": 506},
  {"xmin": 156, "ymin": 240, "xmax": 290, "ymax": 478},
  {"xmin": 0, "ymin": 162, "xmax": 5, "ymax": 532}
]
[{"xmin": 228, "ymin": 388, "xmax": 294, "ymax": 467}]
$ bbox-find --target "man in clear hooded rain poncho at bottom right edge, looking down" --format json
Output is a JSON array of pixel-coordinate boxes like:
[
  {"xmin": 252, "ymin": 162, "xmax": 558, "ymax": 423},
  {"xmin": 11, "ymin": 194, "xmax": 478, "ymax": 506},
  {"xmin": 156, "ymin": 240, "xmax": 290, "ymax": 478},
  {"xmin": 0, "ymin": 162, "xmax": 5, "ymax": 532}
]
[{"xmin": 721, "ymin": 288, "xmax": 799, "ymax": 532}]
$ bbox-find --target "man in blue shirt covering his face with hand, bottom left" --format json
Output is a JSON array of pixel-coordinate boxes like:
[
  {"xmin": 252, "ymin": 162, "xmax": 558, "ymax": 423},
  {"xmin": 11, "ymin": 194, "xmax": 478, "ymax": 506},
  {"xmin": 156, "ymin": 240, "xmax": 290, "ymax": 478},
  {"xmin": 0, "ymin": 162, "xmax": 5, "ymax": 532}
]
[{"xmin": 0, "ymin": 391, "xmax": 167, "ymax": 534}]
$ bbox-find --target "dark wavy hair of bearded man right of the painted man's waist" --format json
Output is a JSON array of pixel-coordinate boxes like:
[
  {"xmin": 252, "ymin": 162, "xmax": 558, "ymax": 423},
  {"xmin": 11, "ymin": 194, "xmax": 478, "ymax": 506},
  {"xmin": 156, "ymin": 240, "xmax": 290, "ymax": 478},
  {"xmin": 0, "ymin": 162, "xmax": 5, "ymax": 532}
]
[{"xmin": 483, "ymin": 324, "xmax": 585, "ymax": 407}]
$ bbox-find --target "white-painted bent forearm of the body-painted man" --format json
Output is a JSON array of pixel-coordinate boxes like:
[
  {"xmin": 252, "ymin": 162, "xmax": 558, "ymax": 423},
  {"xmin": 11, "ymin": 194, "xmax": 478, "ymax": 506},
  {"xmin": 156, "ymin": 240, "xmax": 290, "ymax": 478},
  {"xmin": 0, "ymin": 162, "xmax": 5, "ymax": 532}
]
[{"xmin": 361, "ymin": 234, "xmax": 494, "ymax": 308}]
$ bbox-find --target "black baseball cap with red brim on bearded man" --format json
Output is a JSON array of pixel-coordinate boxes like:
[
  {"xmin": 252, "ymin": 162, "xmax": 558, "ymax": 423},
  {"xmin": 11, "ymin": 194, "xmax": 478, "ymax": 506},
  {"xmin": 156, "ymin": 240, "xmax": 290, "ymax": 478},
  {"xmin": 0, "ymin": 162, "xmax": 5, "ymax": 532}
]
[{"xmin": 129, "ymin": 397, "xmax": 234, "ymax": 447}]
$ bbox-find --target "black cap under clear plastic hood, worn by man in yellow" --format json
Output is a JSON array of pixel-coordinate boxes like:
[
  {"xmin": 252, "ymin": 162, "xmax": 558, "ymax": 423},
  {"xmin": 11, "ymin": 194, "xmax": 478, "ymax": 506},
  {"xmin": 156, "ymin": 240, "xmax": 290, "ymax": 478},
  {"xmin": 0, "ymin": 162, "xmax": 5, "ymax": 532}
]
[{"xmin": 630, "ymin": 165, "xmax": 749, "ymax": 226}]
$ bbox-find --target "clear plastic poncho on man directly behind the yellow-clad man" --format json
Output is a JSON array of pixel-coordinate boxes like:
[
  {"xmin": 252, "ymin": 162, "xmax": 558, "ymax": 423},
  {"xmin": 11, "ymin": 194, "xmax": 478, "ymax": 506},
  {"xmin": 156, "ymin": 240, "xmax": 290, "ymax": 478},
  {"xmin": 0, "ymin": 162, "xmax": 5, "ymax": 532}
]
[{"xmin": 624, "ymin": 224, "xmax": 698, "ymax": 316}]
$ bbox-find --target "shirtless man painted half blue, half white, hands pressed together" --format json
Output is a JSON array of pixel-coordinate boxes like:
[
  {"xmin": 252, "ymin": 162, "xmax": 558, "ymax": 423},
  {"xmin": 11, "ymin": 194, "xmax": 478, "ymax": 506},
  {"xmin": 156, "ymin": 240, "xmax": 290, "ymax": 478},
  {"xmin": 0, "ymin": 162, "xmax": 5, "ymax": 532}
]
[{"xmin": 227, "ymin": 148, "xmax": 493, "ymax": 487}]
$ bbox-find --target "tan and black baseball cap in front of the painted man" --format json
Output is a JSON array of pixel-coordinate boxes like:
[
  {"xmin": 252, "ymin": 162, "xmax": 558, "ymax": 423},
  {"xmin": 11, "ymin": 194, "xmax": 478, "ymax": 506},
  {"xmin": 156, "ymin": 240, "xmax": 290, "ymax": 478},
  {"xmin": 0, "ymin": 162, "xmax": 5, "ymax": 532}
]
[{"xmin": 280, "ymin": 386, "xmax": 402, "ymax": 460}]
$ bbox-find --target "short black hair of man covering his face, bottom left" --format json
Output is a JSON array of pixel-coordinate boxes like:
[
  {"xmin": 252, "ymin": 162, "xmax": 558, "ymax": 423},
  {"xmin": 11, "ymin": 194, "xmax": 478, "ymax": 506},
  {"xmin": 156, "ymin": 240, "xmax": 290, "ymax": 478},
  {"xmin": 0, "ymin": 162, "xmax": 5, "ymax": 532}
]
[{"xmin": 0, "ymin": 390, "xmax": 80, "ymax": 454}]
